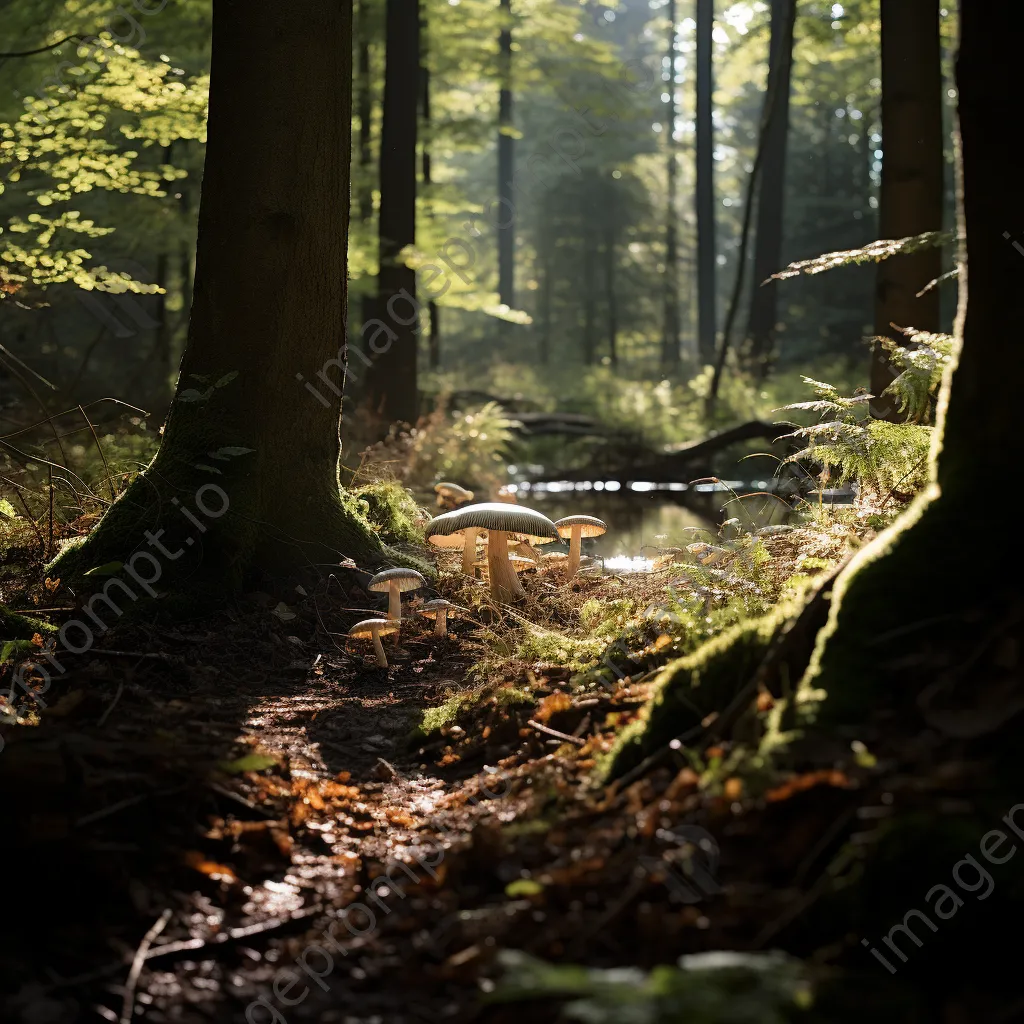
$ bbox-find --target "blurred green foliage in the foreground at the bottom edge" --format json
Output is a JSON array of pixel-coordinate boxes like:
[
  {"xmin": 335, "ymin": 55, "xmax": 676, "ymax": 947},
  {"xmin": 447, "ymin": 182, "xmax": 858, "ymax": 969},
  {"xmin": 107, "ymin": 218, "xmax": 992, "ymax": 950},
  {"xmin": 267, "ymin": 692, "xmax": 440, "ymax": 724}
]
[{"xmin": 489, "ymin": 950, "xmax": 811, "ymax": 1024}]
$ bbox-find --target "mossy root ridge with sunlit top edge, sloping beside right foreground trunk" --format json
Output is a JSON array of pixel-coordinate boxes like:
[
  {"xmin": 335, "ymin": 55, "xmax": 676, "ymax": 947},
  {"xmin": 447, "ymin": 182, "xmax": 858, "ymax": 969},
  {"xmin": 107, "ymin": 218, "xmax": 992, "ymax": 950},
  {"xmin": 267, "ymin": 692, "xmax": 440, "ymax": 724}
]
[{"xmin": 603, "ymin": 603, "xmax": 798, "ymax": 777}]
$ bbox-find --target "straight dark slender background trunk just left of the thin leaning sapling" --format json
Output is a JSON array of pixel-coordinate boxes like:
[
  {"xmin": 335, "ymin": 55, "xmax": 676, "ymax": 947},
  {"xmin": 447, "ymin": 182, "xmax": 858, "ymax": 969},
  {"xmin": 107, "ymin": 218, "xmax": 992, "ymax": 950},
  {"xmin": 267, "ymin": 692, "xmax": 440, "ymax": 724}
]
[{"xmin": 695, "ymin": 0, "xmax": 718, "ymax": 366}]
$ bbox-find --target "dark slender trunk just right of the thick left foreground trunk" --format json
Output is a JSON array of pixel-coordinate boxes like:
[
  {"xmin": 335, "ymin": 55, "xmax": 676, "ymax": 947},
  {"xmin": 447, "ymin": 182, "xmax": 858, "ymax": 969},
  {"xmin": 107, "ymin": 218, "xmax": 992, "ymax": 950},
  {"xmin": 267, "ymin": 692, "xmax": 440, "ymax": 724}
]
[{"xmin": 364, "ymin": 0, "xmax": 420, "ymax": 426}]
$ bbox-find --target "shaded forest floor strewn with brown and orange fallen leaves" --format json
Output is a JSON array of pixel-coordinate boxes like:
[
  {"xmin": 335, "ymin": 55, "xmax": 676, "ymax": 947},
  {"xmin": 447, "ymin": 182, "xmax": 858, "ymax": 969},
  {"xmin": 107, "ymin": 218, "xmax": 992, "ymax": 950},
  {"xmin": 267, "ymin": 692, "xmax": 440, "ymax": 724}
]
[{"xmin": 0, "ymin": 528, "xmax": 1017, "ymax": 1024}]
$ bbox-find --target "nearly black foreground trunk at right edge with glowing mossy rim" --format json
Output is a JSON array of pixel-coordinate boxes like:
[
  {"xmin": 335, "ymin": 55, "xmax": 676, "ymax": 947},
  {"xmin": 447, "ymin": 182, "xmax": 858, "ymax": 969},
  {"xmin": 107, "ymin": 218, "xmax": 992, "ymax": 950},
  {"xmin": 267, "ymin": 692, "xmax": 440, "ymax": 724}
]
[{"xmin": 806, "ymin": 4, "xmax": 1024, "ymax": 721}]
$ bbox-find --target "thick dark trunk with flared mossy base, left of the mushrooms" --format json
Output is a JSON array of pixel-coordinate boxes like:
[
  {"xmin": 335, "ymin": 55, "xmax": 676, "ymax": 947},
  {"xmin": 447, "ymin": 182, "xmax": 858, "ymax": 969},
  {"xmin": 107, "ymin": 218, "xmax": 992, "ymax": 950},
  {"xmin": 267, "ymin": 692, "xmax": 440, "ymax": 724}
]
[{"xmin": 54, "ymin": 0, "xmax": 384, "ymax": 594}]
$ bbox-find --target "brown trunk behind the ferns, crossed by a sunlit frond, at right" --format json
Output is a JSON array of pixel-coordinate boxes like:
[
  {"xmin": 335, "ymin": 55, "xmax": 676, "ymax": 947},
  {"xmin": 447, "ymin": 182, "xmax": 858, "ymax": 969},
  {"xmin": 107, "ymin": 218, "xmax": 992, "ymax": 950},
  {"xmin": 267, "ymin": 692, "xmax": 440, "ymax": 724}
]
[{"xmin": 870, "ymin": 0, "xmax": 943, "ymax": 420}]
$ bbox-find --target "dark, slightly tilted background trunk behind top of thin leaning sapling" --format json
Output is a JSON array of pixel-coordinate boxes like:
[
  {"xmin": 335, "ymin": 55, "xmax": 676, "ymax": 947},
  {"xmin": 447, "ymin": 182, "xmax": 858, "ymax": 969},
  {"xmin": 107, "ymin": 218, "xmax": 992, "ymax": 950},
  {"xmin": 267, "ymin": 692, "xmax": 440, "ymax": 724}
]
[{"xmin": 745, "ymin": 0, "xmax": 796, "ymax": 380}]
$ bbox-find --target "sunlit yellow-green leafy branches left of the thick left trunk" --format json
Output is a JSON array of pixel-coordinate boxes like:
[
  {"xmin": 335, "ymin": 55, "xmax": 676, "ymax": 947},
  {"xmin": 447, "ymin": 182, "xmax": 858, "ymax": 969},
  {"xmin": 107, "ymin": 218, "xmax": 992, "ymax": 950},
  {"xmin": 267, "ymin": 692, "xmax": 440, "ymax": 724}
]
[{"xmin": 0, "ymin": 34, "xmax": 209, "ymax": 300}]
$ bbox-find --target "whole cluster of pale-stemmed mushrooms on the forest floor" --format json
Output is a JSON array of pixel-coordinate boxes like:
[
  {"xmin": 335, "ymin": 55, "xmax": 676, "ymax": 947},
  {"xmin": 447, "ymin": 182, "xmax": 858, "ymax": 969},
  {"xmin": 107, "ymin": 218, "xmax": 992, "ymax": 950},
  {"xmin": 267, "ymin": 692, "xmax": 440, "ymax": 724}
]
[{"xmin": 348, "ymin": 483, "xmax": 607, "ymax": 669}]
